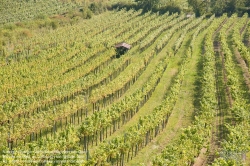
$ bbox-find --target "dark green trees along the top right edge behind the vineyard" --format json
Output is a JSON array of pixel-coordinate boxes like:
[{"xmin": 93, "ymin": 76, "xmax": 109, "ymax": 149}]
[{"xmin": 117, "ymin": 0, "xmax": 250, "ymax": 16}]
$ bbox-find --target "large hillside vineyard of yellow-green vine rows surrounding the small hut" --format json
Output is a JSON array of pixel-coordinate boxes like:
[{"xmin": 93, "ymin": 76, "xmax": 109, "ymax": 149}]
[{"xmin": 0, "ymin": 8, "xmax": 250, "ymax": 166}]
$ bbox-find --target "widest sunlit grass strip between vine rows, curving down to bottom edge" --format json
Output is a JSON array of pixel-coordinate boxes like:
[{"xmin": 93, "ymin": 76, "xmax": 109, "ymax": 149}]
[{"xmin": 127, "ymin": 23, "xmax": 208, "ymax": 166}]
